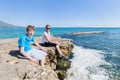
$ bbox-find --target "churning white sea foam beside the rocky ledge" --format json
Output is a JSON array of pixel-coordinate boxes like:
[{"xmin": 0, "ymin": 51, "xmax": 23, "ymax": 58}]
[{"xmin": 65, "ymin": 46, "xmax": 109, "ymax": 80}]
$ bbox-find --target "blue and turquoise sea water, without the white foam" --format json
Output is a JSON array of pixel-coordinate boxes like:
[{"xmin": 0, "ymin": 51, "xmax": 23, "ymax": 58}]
[{"xmin": 0, "ymin": 27, "xmax": 120, "ymax": 80}]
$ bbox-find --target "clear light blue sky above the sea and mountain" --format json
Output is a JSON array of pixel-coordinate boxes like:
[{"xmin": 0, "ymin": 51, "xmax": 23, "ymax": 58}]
[{"xmin": 0, "ymin": 0, "xmax": 120, "ymax": 27}]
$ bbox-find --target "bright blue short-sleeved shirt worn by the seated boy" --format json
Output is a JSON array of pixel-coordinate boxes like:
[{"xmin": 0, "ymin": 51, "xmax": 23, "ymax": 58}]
[{"xmin": 18, "ymin": 34, "xmax": 34, "ymax": 52}]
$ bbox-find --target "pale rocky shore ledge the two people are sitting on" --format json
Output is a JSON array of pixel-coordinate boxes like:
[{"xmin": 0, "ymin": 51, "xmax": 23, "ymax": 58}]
[{"xmin": 0, "ymin": 37, "xmax": 74, "ymax": 80}]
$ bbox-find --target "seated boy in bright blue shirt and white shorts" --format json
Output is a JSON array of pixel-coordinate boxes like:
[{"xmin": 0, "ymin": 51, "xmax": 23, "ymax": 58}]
[{"xmin": 18, "ymin": 25, "xmax": 47, "ymax": 66}]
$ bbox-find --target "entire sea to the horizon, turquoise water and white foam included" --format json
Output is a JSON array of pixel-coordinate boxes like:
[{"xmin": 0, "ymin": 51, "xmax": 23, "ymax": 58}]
[{"xmin": 0, "ymin": 27, "xmax": 120, "ymax": 80}]
